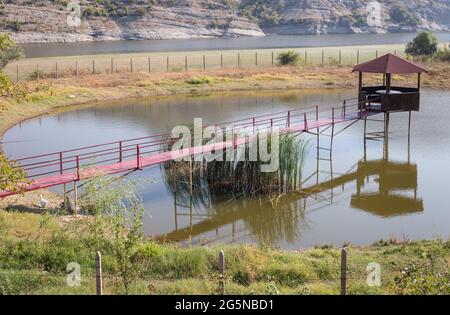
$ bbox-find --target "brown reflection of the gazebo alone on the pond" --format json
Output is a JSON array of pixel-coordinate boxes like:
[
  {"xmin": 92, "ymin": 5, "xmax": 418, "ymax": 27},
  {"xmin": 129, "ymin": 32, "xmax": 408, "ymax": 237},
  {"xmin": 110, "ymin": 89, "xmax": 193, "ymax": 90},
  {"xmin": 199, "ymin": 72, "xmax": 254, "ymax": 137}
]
[{"xmin": 351, "ymin": 159, "xmax": 423, "ymax": 217}]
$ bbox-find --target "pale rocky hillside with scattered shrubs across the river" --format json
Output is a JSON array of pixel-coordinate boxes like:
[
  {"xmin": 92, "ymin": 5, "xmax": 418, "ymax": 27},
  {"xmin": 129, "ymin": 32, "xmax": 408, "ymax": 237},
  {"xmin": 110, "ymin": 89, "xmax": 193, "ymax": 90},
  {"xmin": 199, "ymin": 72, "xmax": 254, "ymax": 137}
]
[{"xmin": 0, "ymin": 0, "xmax": 450, "ymax": 43}]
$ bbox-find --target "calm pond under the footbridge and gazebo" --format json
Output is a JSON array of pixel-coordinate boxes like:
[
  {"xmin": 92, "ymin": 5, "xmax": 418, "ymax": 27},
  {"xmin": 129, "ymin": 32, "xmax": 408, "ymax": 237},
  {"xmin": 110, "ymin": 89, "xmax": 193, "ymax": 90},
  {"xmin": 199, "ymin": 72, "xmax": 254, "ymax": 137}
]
[{"xmin": 3, "ymin": 89, "xmax": 450, "ymax": 249}]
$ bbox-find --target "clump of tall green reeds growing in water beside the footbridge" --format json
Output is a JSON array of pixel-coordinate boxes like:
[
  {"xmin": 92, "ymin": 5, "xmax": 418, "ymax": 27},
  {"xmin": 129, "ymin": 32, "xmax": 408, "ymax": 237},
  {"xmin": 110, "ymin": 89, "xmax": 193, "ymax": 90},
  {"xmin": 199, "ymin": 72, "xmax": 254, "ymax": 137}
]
[{"xmin": 162, "ymin": 135, "xmax": 308, "ymax": 206}]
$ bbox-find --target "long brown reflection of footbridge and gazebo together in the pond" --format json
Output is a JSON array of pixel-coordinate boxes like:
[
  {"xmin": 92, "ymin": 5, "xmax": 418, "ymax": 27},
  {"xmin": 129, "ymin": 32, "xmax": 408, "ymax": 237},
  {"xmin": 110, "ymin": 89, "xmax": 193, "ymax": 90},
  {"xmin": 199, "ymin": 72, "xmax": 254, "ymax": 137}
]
[{"xmin": 159, "ymin": 131, "xmax": 423, "ymax": 241}]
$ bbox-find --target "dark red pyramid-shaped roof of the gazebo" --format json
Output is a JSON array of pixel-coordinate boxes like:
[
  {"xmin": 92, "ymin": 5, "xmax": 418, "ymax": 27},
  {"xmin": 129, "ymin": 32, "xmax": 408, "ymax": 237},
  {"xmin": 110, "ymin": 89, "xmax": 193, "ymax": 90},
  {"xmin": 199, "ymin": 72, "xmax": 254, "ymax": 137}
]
[{"xmin": 353, "ymin": 54, "xmax": 428, "ymax": 74}]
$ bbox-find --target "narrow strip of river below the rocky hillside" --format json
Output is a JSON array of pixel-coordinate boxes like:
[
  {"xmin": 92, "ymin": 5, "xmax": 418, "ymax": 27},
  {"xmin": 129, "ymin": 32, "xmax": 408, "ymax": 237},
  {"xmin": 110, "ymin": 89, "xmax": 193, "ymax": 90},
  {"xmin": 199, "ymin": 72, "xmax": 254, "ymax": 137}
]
[{"xmin": 21, "ymin": 33, "xmax": 450, "ymax": 58}]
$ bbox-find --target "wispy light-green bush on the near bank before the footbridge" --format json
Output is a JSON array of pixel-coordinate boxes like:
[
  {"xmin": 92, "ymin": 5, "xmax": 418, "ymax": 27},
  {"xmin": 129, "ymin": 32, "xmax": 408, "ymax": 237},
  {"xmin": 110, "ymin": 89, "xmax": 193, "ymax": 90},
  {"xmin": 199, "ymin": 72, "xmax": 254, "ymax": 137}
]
[{"xmin": 83, "ymin": 176, "xmax": 144, "ymax": 294}]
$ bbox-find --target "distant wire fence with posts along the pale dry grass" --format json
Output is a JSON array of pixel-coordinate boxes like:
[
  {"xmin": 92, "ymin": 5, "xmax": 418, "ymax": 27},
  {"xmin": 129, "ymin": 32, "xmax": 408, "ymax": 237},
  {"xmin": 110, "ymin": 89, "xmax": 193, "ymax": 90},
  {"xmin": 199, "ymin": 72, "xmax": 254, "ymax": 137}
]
[{"xmin": 5, "ymin": 47, "xmax": 412, "ymax": 81}]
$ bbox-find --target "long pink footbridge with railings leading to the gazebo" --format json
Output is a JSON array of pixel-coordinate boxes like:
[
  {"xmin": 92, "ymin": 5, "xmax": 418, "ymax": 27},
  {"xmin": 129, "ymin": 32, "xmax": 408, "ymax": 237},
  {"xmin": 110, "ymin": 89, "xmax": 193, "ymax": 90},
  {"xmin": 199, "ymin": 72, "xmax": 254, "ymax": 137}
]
[{"xmin": 0, "ymin": 102, "xmax": 378, "ymax": 198}]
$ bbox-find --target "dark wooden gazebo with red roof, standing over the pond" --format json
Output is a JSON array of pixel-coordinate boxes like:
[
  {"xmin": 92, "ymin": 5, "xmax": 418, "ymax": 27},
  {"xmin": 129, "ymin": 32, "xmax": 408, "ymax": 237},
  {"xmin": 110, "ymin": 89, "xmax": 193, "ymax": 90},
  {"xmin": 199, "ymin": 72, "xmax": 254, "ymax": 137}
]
[{"xmin": 353, "ymin": 54, "xmax": 428, "ymax": 113}]
